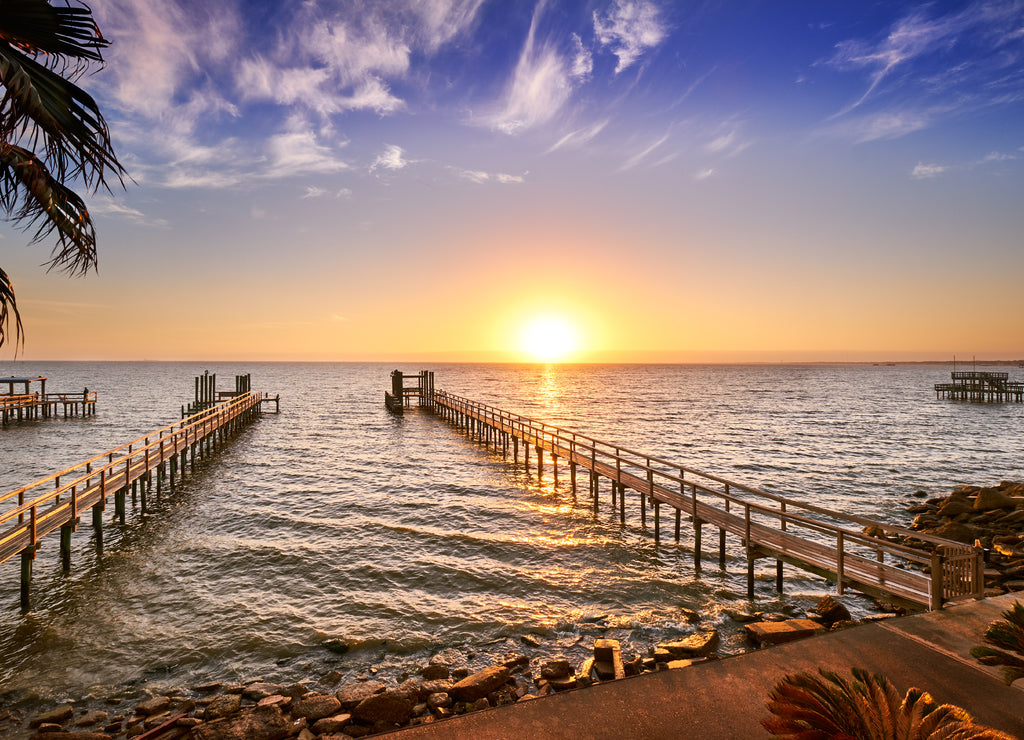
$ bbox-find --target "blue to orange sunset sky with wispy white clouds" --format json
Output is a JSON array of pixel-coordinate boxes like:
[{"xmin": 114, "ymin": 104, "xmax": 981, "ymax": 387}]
[{"xmin": 0, "ymin": 0, "xmax": 1024, "ymax": 362}]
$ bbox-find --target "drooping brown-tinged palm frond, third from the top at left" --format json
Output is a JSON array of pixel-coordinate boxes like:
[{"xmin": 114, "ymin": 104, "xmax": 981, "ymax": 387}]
[{"xmin": 0, "ymin": 143, "xmax": 96, "ymax": 274}]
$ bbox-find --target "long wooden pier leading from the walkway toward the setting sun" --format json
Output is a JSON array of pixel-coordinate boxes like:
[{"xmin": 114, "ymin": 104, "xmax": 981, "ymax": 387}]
[{"xmin": 397, "ymin": 384, "xmax": 984, "ymax": 609}]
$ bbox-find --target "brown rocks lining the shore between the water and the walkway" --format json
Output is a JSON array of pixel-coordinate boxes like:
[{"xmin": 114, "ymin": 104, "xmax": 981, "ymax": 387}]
[{"xmin": 0, "ymin": 481, "xmax": 1024, "ymax": 740}]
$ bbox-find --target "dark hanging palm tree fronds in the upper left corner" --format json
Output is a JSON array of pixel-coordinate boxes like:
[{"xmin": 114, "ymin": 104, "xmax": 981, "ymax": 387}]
[{"xmin": 0, "ymin": 0, "xmax": 125, "ymax": 346}]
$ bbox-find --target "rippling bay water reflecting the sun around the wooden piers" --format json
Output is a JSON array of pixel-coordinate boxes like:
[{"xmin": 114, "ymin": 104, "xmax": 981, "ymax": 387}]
[{"xmin": 0, "ymin": 362, "xmax": 1024, "ymax": 711}]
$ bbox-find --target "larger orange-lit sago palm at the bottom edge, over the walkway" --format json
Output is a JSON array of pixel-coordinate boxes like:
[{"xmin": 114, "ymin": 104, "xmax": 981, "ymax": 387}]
[{"xmin": 761, "ymin": 668, "xmax": 1013, "ymax": 740}]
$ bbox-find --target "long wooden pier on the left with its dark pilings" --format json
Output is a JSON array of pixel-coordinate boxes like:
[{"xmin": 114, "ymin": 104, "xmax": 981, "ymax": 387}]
[{"xmin": 0, "ymin": 391, "xmax": 264, "ymax": 606}]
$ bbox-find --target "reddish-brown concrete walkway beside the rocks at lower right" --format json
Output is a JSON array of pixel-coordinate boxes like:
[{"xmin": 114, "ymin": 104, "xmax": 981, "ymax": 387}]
[{"xmin": 387, "ymin": 594, "xmax": 1024, "ymax": 740}]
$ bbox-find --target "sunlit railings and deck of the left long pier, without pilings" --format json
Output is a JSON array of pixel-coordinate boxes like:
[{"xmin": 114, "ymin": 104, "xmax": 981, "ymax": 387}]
[{"xmin": 0, "ymin": 392, "xmax": 261, "ymax": 537}]
